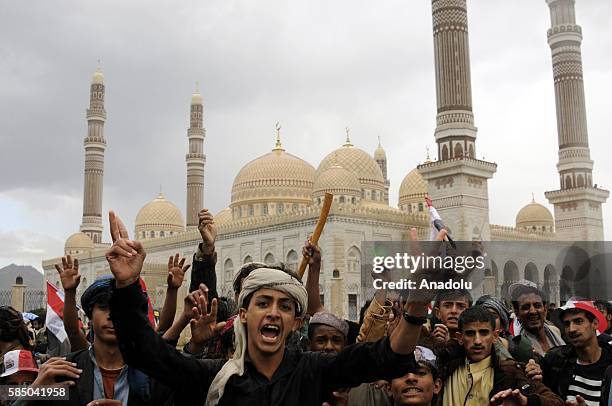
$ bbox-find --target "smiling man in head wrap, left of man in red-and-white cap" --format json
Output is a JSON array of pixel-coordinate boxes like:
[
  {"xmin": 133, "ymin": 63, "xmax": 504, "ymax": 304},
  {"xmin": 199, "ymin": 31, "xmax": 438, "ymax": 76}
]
[{"xmin": 508, "ymin": 280, "xmax": 565, "ymax": 360}]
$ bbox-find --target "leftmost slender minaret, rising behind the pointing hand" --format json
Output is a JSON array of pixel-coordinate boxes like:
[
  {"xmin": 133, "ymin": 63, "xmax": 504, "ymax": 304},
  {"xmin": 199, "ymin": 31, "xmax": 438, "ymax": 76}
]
[{"xmin": 81, "ymin": 68, "xmax": 106, "ymax": 244}]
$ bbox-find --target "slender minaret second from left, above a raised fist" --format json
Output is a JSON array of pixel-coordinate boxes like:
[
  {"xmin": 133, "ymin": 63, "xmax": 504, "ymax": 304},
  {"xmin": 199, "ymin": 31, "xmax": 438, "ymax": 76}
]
[{"xmin": 185, "ymin": 87, "xmax": 206, "ymax": 227}]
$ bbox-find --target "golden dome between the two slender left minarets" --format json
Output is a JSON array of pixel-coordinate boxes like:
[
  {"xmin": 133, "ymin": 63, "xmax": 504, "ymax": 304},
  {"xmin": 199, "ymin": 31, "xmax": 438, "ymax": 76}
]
[{"xmin": 134, "ymin": 193, "xmax": 185, "ymax": 238}]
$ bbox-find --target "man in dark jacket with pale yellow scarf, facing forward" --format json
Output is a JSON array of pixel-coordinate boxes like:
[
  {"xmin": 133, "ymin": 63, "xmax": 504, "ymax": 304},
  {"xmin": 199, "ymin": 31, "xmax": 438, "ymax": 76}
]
[{"xmin": 441, "ymin": 305, "xmax": 563, "ymax": 406}]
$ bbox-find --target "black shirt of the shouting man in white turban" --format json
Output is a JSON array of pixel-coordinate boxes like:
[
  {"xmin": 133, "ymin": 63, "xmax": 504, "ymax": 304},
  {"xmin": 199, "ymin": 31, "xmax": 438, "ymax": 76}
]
[{"xmin": 110, "ymin": 283, "xmax": 416, "ymax": 406}]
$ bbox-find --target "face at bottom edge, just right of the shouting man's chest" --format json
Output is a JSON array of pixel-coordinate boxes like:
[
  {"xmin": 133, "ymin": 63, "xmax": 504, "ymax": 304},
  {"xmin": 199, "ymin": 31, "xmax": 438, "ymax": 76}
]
[{"xmin": 391, "ymin": 364, "xmax": 442, "ymax": 406}]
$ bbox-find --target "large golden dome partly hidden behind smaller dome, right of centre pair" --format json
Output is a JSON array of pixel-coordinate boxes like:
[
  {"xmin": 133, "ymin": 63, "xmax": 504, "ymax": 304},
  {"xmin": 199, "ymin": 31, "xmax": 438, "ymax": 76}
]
[{"xmin": 316, "ymin": 143, "xmax": 385, "ymax": 193}]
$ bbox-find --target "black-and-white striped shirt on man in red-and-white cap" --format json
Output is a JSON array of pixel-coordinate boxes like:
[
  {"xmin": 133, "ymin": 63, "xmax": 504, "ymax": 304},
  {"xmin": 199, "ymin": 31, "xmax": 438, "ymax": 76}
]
[{"xmin": 566, "ymin": 351, "xmax": 609, "ymax": 406}]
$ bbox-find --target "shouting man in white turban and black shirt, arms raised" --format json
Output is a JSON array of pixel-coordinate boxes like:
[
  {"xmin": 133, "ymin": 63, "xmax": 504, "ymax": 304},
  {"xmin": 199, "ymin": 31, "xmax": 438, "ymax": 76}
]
[{"xmin": 107, "ymin": 213, "xmax": 427, "ymax": 406}]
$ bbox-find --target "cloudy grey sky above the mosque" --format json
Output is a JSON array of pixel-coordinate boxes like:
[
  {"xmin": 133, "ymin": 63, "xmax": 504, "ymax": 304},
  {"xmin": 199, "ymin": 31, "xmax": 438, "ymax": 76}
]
[{"xmin": 0, "ymin": 0, "xmax": 612, "ymax": 269}]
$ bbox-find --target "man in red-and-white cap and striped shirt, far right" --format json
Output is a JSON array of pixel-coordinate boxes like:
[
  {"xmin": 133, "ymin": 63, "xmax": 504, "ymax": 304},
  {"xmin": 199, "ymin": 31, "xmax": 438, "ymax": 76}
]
[{"xmin": 541, "ymin": 299, "xmax": 612, "ymax": 406}]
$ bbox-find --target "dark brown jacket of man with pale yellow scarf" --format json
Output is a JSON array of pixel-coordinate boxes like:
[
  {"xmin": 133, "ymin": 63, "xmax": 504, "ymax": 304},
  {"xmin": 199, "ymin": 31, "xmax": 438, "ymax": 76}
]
[{"xmin": 438, "ymin": 340, "xmax": 565, "ymax": 406}]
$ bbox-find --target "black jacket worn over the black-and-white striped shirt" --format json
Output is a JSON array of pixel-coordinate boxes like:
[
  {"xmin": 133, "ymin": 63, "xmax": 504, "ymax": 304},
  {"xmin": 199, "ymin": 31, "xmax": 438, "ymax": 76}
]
[{"xmin": 540, "ymin": 336, "xmax": 612, "ymax": 404}]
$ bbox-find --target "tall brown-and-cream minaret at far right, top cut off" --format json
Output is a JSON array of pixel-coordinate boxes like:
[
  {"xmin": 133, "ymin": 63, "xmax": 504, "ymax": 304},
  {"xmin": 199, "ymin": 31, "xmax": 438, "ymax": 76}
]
[{"xmin": 546, "ymin": 0, "xmax": 609, "ymax": 241}]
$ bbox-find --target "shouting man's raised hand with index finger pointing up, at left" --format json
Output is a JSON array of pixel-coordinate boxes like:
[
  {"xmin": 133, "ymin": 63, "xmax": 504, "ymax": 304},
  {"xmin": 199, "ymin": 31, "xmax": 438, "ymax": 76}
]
[{"xmin": 106, "ymin": 211, "xmax": 147, "ymax": 288}]
